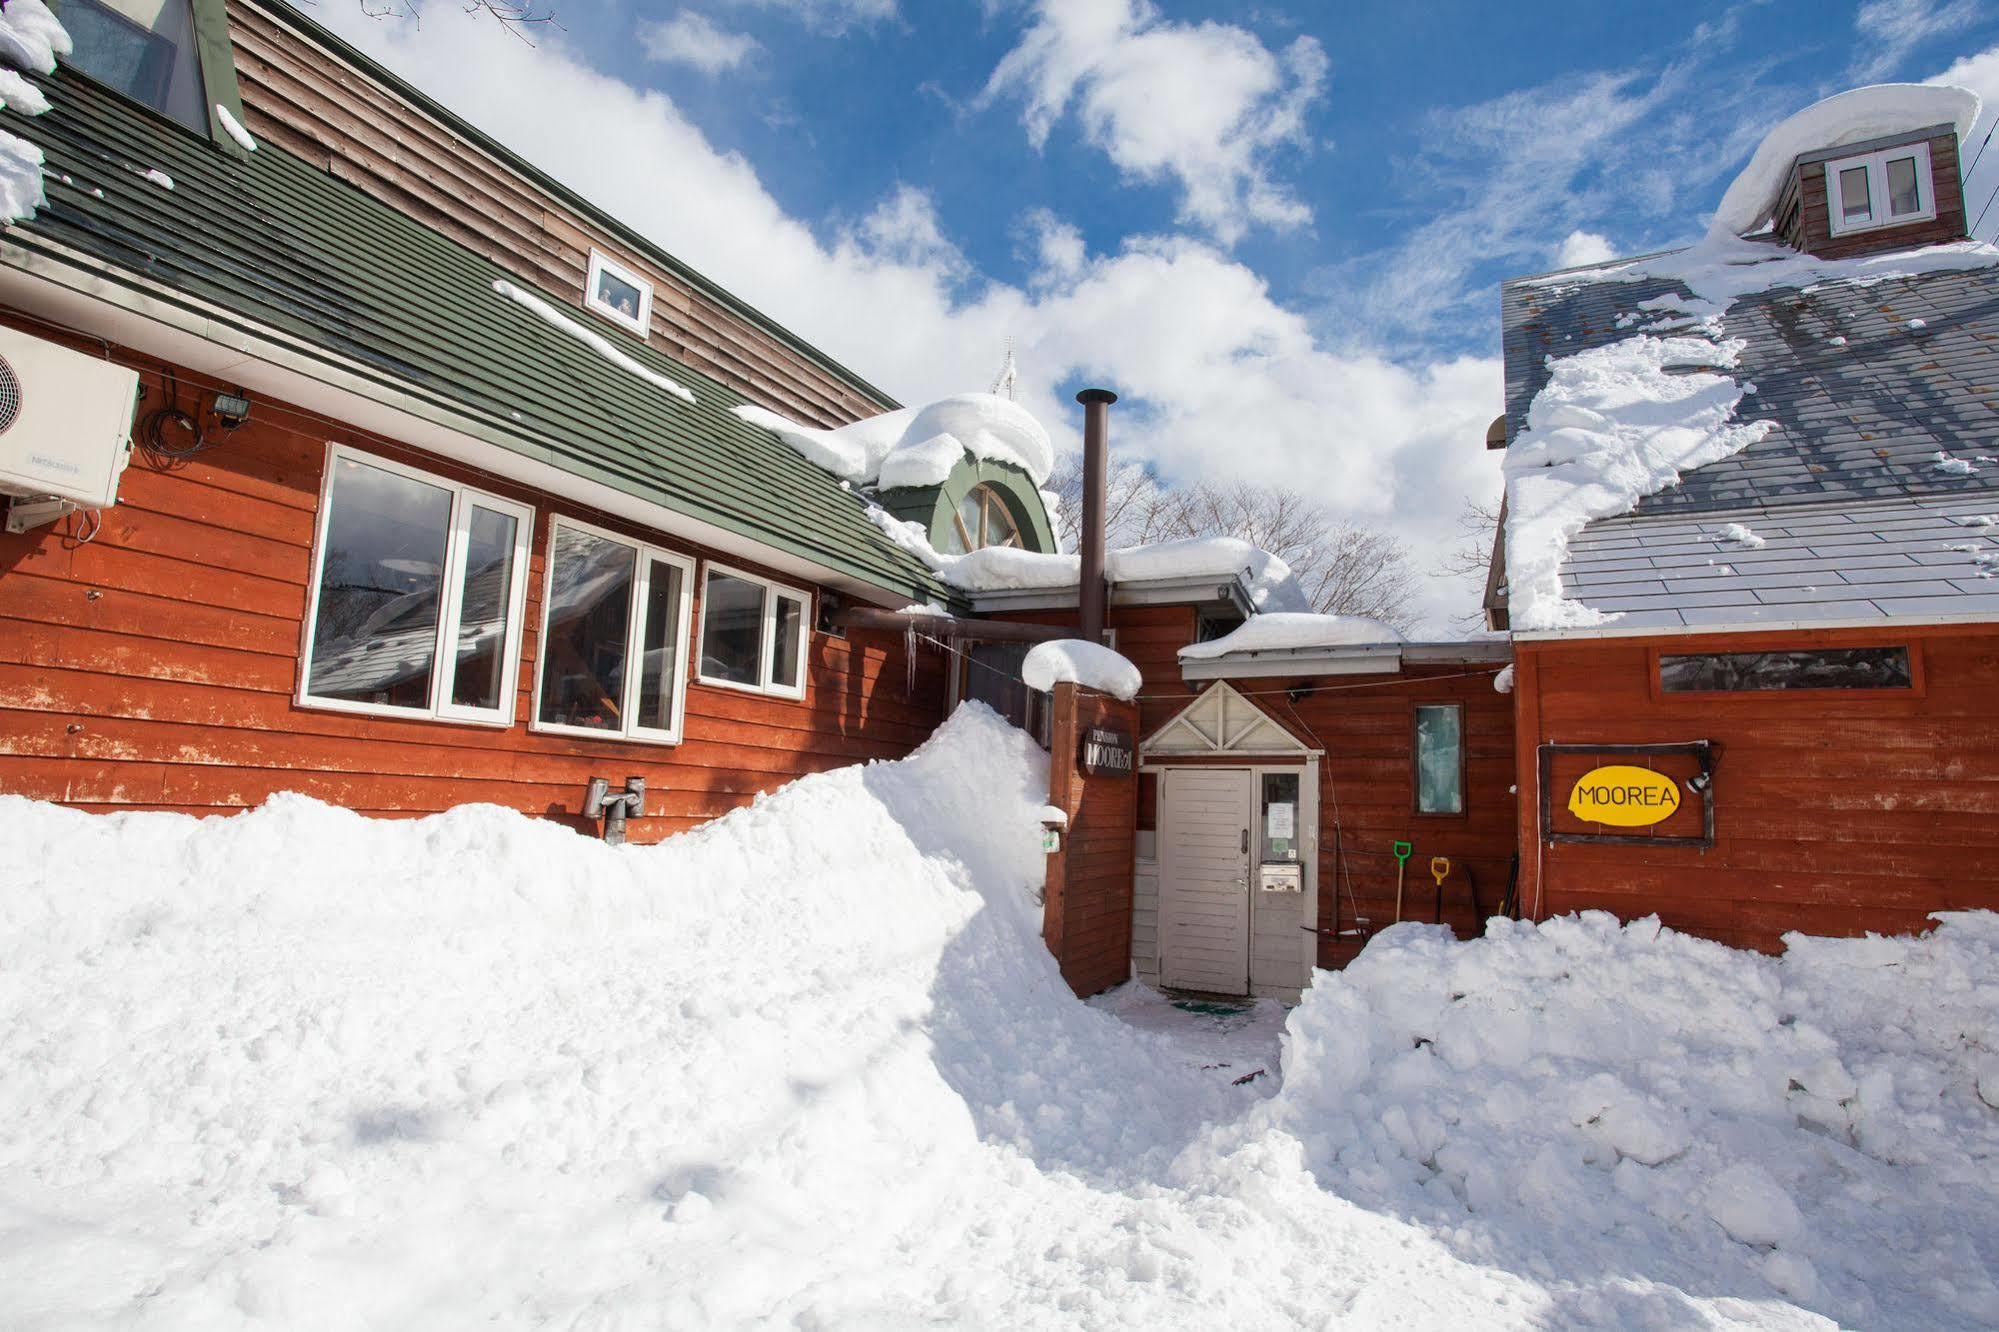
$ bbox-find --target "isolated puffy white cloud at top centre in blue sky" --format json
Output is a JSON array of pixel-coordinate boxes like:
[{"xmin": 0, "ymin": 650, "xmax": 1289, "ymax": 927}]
[{"xmin": 984, "ymin": 0, "xmax": 1327, "ymax": 244}]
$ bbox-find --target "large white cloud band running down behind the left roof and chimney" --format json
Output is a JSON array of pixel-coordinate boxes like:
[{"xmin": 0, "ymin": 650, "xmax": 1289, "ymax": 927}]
[{"xmin": 307, "ymin": 6, "xmax": 1501, "ymax": 630}]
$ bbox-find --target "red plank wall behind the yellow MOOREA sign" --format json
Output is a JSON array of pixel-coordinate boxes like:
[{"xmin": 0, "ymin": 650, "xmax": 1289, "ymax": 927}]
[{"xmin": 1515, "ymin": 626, "xmax": 1999, "ymax": 952}]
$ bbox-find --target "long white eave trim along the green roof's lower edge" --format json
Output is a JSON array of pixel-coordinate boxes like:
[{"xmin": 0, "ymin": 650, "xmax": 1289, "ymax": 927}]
[{"xmin": 0, "ymin": 234, "xmax": 914, "ymax": 610}]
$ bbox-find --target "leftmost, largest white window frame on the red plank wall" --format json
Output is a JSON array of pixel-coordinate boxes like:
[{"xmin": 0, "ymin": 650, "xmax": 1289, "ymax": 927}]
[{"xmin": 294, "ymin": 440, "xmax": 534, "ymax": 728}]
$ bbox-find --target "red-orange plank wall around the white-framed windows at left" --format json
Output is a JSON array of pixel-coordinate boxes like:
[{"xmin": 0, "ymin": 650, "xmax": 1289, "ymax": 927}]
[{"xmin": 0, "ymin": 330, "xmax": 946, "ymax": 840}]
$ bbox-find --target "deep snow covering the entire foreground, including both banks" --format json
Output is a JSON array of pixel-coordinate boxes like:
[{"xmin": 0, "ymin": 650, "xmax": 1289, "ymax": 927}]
[{"xmin": 0, "ymin": 708, "xmax": 1999, "ymax": 1328}]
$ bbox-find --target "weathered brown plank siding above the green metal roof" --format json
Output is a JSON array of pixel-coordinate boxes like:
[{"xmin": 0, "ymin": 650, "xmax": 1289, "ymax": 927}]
[{"xmin": 228, "ymin": 2, "xmax": 884, "ymax": 426}]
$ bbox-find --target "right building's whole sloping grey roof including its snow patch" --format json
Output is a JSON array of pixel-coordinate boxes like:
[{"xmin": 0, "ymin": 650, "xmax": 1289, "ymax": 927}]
[{"xmin": 1503, "ymin": 236, "xmax": 1999, "ymax": 630}]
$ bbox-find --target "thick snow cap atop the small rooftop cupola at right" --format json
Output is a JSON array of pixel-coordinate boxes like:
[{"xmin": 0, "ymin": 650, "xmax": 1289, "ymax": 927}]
[{"xmin": 1709, "ymin": 84, "xmax": 1979, "ymax": 236}]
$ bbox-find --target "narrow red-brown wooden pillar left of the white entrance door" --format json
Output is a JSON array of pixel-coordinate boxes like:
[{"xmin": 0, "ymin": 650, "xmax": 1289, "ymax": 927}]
[{"xmin": 1041, "ymin": 684, "xmax": 1137, "ymax": 996}]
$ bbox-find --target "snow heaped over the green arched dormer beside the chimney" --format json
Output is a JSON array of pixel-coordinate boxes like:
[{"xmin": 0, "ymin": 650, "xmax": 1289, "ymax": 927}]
[{"xmin": 732, "ymin": 394, "xmax": 1055, "ymax": 490}]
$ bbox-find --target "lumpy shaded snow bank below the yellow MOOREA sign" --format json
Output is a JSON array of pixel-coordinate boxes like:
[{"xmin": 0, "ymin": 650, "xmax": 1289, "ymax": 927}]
[{"xmin": 1269, "ymin": 912, "xmax": 1999, "ymax": 1328}]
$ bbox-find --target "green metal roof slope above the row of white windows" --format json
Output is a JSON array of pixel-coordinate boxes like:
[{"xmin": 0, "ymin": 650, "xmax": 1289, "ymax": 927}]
[{"xmin": 0, "ymin": 72, "xmax": 952, "ymax": 600}]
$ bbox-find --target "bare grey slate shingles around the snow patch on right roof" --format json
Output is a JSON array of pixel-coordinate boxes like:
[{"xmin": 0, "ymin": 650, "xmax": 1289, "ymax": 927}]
[{"xmin": 1501, "ymin": 243, "xmax": 1999, "ymax": 628}]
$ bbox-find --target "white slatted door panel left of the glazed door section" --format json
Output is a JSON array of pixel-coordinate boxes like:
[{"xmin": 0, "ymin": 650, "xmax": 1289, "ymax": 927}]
[{"xmin": 1159, "ymin": 768, "xmax": 1253, "ymax": 994}]
